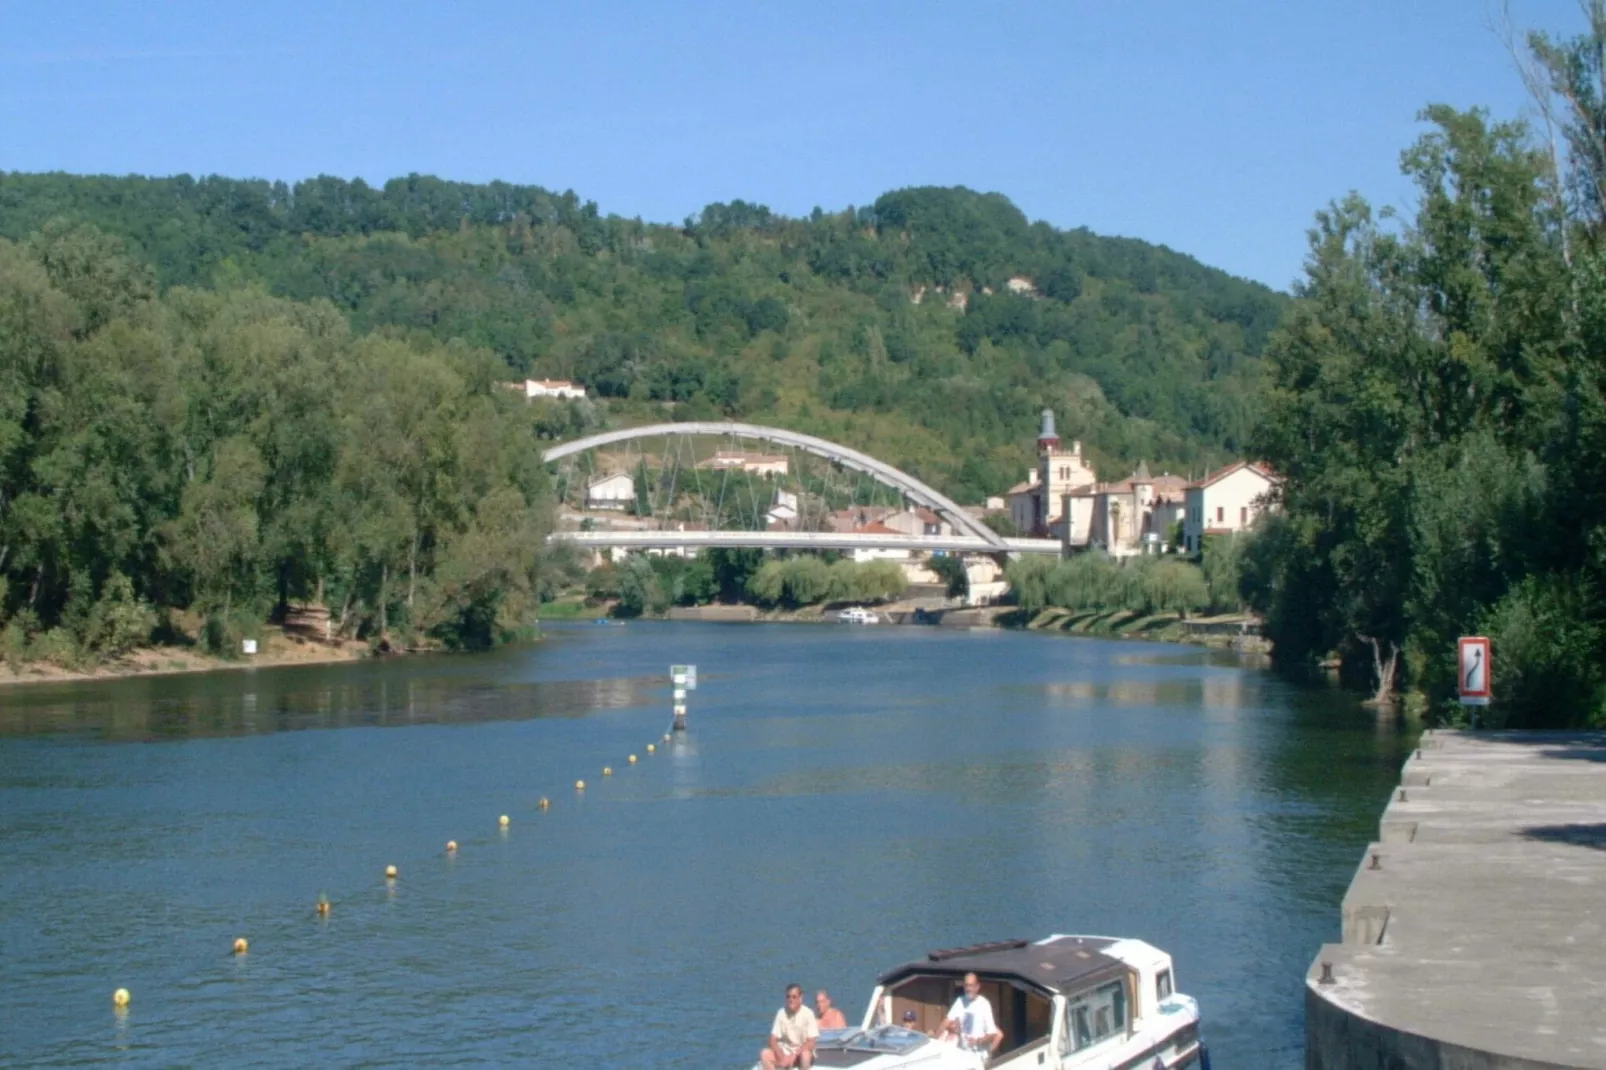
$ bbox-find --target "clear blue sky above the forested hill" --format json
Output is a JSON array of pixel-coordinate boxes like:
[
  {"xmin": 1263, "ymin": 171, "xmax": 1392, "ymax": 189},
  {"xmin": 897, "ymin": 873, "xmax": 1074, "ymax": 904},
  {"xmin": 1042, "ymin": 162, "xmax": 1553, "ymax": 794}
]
[{"xmin": 0, "ymin": 0, "xmax": 1582, "ymax": 288}]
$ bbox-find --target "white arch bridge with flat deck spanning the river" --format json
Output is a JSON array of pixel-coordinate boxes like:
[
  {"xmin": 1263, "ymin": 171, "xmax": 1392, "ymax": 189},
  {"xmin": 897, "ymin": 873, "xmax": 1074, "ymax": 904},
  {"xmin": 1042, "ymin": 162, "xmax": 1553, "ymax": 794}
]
[{"xmin": 543, "ymin": 421, "xmax": 1062, "ymax": 556}]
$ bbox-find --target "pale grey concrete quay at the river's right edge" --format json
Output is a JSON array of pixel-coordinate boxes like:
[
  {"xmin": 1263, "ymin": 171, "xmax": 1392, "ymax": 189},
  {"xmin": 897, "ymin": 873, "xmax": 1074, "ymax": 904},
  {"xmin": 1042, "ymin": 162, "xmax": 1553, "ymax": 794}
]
[{"xmin": 1306, "ymin": 731, "xmax": 1606, "ymax": 1070}]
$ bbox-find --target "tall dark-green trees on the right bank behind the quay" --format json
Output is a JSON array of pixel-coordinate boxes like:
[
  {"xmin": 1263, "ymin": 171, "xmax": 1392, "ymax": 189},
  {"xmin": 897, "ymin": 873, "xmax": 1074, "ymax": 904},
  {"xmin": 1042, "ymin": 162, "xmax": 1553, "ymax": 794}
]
[{"xmin": 1246, "ymin": 18, "xmax": 1606, "ymax": 726}]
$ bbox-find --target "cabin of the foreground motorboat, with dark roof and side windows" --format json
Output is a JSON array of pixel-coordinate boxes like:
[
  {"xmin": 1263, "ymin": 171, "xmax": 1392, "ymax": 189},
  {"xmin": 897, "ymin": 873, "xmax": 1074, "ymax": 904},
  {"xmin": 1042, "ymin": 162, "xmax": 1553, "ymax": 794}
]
[{"xmin": 862, "ymin": 935, "xmax": 1196, "ymax": 1068}]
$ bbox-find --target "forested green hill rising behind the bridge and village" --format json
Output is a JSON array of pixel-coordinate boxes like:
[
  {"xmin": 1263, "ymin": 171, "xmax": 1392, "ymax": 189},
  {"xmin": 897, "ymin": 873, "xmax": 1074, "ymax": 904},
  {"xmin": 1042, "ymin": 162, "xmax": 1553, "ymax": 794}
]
[{"xmin": 0, "ymin": 174, "xmax": 1286, "ymax": 500}]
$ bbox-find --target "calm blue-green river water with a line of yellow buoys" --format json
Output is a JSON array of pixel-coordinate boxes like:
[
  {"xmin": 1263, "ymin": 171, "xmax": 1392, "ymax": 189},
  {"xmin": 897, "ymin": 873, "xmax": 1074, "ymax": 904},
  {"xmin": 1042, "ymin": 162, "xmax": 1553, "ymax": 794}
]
[{"xmin": 0, "ymin": 623, "xmax": 1408, "ymax": 1070}]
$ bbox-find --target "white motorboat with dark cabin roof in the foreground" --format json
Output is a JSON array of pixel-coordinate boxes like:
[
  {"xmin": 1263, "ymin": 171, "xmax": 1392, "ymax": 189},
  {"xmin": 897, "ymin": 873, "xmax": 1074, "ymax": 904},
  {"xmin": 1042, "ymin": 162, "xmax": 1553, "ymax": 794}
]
[{"xmin": 751, "ymin": 935, "xmax": 1209, "ymax": 1070}]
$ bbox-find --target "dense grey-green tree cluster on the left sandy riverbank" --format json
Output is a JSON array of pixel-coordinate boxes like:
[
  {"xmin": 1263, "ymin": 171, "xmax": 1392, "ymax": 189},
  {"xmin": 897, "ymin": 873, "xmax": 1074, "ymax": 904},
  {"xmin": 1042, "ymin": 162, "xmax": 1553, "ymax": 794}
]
[{"xmin": 0, "ymin": 226, "xmax": 567, "ymax": 649}]
